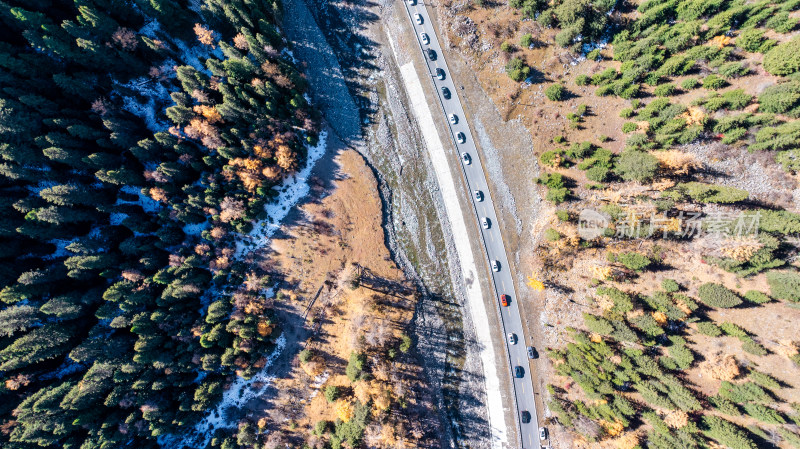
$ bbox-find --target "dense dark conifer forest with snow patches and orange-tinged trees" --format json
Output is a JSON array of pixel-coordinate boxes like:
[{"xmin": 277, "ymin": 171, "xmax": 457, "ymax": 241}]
[{"xmin": 0, "ymin": 0, "xmax": 318, "ymax": 449}]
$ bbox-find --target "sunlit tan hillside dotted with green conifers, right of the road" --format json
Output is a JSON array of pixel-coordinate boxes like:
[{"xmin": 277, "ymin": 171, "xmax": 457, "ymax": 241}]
[{"xmin": 454, "ymin": 0, "xmax": 800, "ymax": 449}]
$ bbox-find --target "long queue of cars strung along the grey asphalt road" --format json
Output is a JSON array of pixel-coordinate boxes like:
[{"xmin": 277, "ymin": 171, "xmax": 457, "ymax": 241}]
[{"xmin": 406, "ymin": 0, "xmax": 547, "ymax": 449}]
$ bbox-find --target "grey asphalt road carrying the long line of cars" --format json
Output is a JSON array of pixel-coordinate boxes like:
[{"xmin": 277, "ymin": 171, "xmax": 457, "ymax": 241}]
[{"xmin": 403, "ymin": 0, "xmax": 540, "ymax": 448}]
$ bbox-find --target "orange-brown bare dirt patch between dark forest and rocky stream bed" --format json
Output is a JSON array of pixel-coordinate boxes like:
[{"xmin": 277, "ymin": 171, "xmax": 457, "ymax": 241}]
[{"xmin": 255, "ymin": 150, "xmax": 435, "ymax": 447}]
